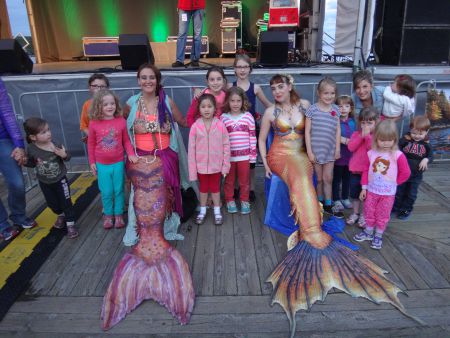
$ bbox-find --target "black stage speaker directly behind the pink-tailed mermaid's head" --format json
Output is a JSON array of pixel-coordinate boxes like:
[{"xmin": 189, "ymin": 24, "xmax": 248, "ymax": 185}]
[{"xmin": 119, "ymin": 34, "xmax": 155, "ymax": 70}]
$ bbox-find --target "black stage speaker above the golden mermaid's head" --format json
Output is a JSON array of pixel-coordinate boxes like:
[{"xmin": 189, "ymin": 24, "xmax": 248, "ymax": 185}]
[{"xmin": 256, "ymin": 31, "xmax": 289, "ymax": 66}]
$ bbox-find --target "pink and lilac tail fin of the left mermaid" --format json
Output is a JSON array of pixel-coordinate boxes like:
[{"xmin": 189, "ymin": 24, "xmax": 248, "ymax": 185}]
[{"xmin": 101, "ymin": 248, "xmax": 195, "ymax": 330}]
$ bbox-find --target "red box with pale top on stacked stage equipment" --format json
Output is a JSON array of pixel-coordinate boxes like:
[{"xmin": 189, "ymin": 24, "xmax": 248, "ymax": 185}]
[{"xmin": 269, "ymin": 0, "xmax": 300, "ymax": 28}]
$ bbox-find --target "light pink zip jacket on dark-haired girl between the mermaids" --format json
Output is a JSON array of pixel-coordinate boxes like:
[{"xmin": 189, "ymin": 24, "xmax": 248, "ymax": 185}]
[{"xmin": 188, "ymin": 117, "xmax": 230, "ymax": 181}]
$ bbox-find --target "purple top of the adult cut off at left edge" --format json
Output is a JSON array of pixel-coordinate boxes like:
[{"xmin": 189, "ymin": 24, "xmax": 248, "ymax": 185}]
[{"xmin": 0, "ymin": 79, "xmax": 25, "ymax": 148}]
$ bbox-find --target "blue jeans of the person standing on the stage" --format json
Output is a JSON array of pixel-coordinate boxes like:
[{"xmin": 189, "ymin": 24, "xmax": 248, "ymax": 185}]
[{"xmin": 177, "ymin": 9, "xmax": 205, "ymax": 62}]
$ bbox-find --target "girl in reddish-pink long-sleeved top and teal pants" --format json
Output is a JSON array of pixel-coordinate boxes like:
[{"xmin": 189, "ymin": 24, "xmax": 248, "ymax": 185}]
[{"xmin": 88, "ymin": 90, "xmax": 138, "ymax": 229}]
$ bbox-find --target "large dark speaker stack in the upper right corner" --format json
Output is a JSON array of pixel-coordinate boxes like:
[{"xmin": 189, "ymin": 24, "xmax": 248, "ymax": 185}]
[{"xmin": 375, "ymin": 0, "xmax": 450, "ymax": 65}]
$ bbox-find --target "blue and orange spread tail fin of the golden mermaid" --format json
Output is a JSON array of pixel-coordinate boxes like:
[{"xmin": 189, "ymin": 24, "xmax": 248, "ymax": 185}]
[{"xmin": 267, "ymin": 241, "xmax": 423, "ymax": 337}]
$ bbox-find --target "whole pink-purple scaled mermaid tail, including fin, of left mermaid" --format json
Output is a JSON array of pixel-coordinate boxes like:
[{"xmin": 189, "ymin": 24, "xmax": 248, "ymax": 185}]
[{"xmin": 101, "ymin": 156, "xmax": 195, "ymax": 330}]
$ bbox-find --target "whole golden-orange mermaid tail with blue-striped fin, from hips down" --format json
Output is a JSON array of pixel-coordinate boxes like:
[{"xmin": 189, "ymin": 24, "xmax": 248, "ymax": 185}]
[{"xmin": 267, "ymin": 133, "xmax": 422, "ymax": 337}]
